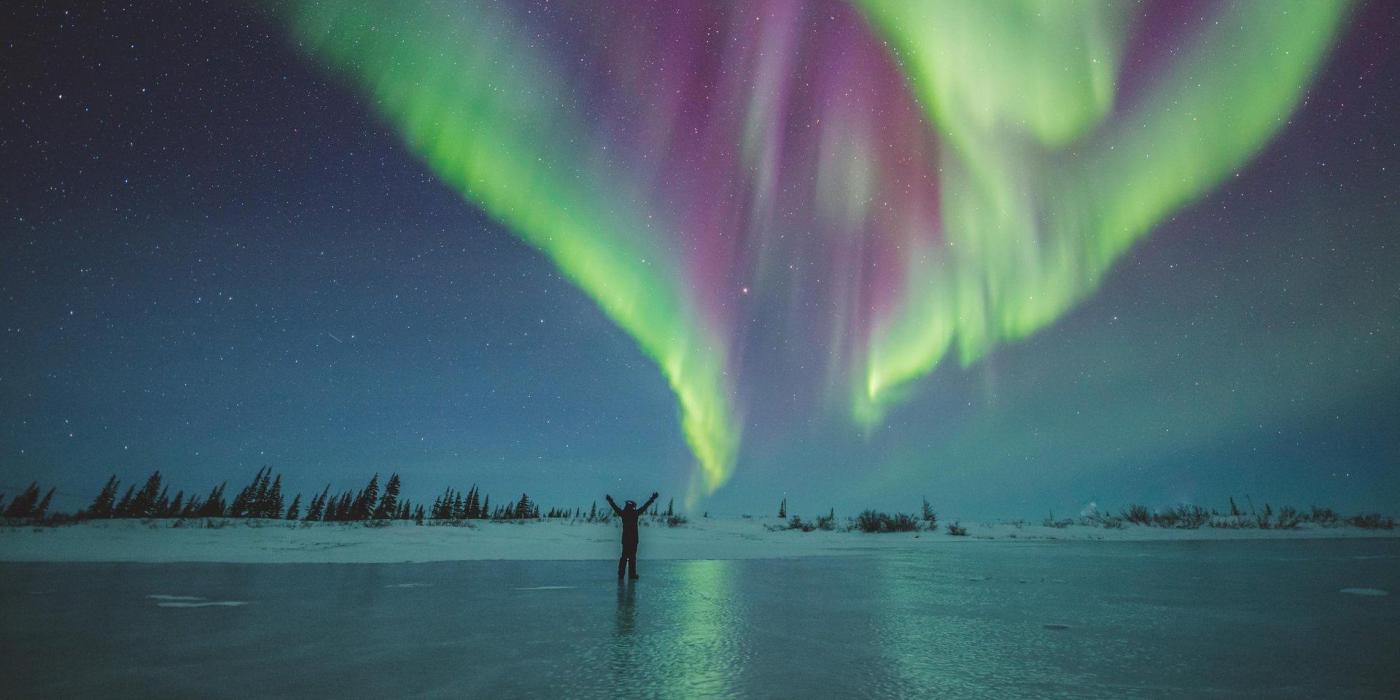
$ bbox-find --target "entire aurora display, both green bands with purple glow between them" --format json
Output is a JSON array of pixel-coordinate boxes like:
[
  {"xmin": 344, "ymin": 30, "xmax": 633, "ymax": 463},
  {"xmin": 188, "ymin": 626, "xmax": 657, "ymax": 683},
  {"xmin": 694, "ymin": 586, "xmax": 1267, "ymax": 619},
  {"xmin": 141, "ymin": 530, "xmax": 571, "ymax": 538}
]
[{"xmin": 275, "ymin": 0, "xmax": 1347, "ymax": 496}]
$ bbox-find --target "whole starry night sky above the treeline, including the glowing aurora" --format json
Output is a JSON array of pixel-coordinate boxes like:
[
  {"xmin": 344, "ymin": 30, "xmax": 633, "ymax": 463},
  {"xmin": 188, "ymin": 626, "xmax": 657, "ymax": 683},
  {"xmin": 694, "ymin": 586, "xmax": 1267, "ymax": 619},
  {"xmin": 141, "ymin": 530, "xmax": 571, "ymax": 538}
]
[{"xmin": 0, "ymin": 0, "xmax": 1400, "ymax": 517}]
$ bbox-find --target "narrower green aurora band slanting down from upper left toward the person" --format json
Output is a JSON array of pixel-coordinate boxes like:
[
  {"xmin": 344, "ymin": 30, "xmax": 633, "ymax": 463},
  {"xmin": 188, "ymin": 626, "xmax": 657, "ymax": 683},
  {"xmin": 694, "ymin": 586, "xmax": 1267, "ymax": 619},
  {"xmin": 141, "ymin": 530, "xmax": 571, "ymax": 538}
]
[{"xmin": 268, "ymin": 1, "xmax": 739, "ymax": 494}]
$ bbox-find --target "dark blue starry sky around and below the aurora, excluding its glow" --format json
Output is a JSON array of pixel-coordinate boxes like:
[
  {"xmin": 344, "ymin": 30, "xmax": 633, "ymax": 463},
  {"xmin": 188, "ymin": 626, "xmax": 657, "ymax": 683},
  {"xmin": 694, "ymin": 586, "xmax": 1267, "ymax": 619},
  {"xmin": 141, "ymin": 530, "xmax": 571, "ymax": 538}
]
[{"xmin": 0, "ymin": 3, "xmax": 1400, "ymax": 515}]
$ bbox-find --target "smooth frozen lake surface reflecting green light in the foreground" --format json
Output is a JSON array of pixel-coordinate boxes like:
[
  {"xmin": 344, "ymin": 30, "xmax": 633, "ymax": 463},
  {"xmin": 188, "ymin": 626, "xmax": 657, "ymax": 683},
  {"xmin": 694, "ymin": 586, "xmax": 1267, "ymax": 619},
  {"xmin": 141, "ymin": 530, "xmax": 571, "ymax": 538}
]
[{"xmin": 0, "ymin": 539, "xmax": 1400, "ymax": 697}]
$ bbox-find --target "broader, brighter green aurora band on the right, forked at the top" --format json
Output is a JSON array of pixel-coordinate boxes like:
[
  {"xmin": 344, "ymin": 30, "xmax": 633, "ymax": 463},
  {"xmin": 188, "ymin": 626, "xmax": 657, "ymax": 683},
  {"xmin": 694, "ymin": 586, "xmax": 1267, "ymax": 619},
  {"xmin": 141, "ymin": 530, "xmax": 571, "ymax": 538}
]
[{"xmin": 854, "ymin": 0, "xmax": 1350, "ymax": 423}]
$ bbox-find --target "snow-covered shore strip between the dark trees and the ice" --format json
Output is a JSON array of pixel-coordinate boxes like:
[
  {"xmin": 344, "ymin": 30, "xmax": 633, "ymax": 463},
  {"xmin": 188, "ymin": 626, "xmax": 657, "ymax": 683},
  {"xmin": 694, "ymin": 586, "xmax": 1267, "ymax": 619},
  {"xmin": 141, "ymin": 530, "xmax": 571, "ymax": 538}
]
[{"xmin": 0, "ymin": 518, "xmax": 1400, "ymax": 563}]
